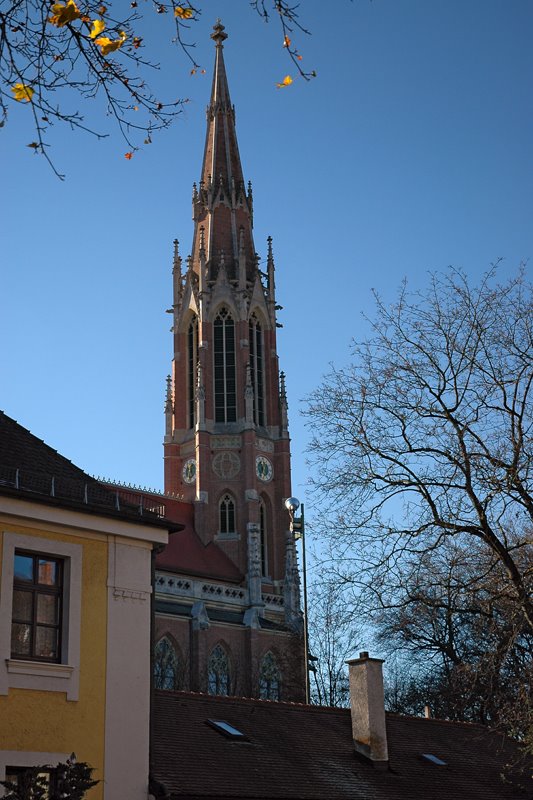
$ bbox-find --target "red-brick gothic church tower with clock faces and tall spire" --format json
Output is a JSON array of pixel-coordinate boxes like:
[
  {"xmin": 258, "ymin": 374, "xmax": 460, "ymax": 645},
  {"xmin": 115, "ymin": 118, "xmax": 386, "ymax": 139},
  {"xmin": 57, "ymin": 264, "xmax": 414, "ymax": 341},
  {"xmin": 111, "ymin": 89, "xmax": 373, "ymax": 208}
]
[{"xmin": 156, "ymin": 21, "xmax": 304, "ymax": 699}]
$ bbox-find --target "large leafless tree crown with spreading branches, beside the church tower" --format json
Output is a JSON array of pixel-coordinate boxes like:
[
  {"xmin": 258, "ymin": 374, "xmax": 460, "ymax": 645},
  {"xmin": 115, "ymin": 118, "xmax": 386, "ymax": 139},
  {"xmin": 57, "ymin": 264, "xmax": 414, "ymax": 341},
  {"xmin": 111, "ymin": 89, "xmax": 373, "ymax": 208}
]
[{"xmin": 307, "ymin": 268, "xmax": 533, "ymax": 632}]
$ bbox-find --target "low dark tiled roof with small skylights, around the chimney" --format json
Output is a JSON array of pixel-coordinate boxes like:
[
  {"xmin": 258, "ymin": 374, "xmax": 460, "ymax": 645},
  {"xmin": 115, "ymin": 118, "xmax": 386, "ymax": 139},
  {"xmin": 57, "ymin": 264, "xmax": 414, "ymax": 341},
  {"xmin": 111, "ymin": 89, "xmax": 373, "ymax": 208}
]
[{"xmin": 153, "ymin": 692, "xmax": 533, "ymax": 800}]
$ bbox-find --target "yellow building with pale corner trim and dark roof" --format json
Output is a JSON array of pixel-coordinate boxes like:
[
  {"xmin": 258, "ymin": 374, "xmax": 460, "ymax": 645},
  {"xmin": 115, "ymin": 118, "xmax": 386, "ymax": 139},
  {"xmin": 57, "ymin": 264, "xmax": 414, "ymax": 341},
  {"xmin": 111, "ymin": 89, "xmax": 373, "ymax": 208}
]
[{"xmin": 0, "ymin": 412, "xmax": 181, "ymax": 800}]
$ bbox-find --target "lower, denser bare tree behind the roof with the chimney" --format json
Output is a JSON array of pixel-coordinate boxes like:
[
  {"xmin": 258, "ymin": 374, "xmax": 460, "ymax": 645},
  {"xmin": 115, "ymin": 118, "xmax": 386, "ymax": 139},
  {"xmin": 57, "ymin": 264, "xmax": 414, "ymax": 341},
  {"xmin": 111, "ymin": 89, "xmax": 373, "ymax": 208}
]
[{"xmin": 376, "ymin": 539, "xmax": 533, "ymax": 740}]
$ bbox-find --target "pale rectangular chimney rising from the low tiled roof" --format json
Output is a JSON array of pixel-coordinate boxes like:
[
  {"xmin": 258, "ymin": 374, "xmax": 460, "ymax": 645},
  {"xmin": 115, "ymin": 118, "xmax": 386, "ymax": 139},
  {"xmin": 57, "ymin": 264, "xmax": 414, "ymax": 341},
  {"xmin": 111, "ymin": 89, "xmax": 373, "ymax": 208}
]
[{"xmin": 346, "ymin": 652, "xmax": 389, "ymax": 766}]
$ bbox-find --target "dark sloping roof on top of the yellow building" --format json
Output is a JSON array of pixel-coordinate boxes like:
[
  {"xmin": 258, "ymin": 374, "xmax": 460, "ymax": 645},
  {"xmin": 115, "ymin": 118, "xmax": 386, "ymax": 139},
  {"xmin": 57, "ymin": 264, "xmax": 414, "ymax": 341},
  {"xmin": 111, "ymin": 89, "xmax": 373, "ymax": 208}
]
[{"xmin": 0, "ymin": 411, "xmax": 181, "ymax": 531}]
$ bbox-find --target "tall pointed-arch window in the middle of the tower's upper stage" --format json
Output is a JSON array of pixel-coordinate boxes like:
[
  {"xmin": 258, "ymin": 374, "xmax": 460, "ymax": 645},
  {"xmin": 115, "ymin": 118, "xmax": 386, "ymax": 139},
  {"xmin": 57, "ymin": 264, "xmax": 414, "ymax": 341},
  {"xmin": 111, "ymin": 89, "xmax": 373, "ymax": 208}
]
[{"xmin": 213, "ymin": 308, "xmax": 237, "ymax": 422}]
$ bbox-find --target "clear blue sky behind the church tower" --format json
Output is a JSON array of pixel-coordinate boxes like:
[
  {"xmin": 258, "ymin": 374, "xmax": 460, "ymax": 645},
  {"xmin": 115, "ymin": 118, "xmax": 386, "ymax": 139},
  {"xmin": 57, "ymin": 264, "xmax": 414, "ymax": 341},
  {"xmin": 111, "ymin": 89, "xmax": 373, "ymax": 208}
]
[{"xmin": 0, "ymin": 0, "xmax": 533, "ymax": 512}]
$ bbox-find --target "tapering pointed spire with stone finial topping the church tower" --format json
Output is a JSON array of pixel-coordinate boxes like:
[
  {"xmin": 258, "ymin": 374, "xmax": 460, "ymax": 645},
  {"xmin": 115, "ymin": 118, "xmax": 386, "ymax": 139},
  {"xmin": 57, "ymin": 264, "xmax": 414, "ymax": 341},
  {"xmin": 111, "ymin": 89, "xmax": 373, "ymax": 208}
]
[{"xmin": 192, "ymin": 20, "xmax": 255, "ymax": 283}]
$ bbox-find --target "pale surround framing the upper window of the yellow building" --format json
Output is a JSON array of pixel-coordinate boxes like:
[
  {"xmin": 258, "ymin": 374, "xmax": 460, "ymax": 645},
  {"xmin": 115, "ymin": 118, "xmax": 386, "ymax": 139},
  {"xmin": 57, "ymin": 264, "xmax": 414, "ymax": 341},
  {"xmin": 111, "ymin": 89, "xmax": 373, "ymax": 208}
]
[{"xmin": 0, "ymin": 531, "xmax": 82, "ymax": 700}]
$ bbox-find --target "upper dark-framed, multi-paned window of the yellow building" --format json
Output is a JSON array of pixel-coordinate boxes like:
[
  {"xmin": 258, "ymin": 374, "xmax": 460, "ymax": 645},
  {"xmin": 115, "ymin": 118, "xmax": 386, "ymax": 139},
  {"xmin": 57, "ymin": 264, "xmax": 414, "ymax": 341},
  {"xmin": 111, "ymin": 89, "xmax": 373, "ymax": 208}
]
[{"xmin": 11, "ymin": 550, "xmax": 63, "ymax": 662}]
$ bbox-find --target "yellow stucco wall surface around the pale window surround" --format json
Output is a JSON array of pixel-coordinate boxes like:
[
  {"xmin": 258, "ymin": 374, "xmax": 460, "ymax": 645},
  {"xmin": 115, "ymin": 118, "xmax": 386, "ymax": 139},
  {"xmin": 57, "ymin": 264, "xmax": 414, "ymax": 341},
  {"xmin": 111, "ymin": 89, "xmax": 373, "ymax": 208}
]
[{"xmin": 0, "ymin": 516, "xmax": 108, "ymax": 800}]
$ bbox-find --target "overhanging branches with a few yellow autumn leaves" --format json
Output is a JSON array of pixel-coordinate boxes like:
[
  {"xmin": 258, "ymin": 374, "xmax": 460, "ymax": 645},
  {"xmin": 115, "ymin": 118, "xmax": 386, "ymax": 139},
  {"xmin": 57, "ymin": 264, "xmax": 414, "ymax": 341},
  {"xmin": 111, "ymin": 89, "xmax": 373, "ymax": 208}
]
[{"xmin": 0, "ymin": 0, "xmax": 314, "ymax": 177}]
